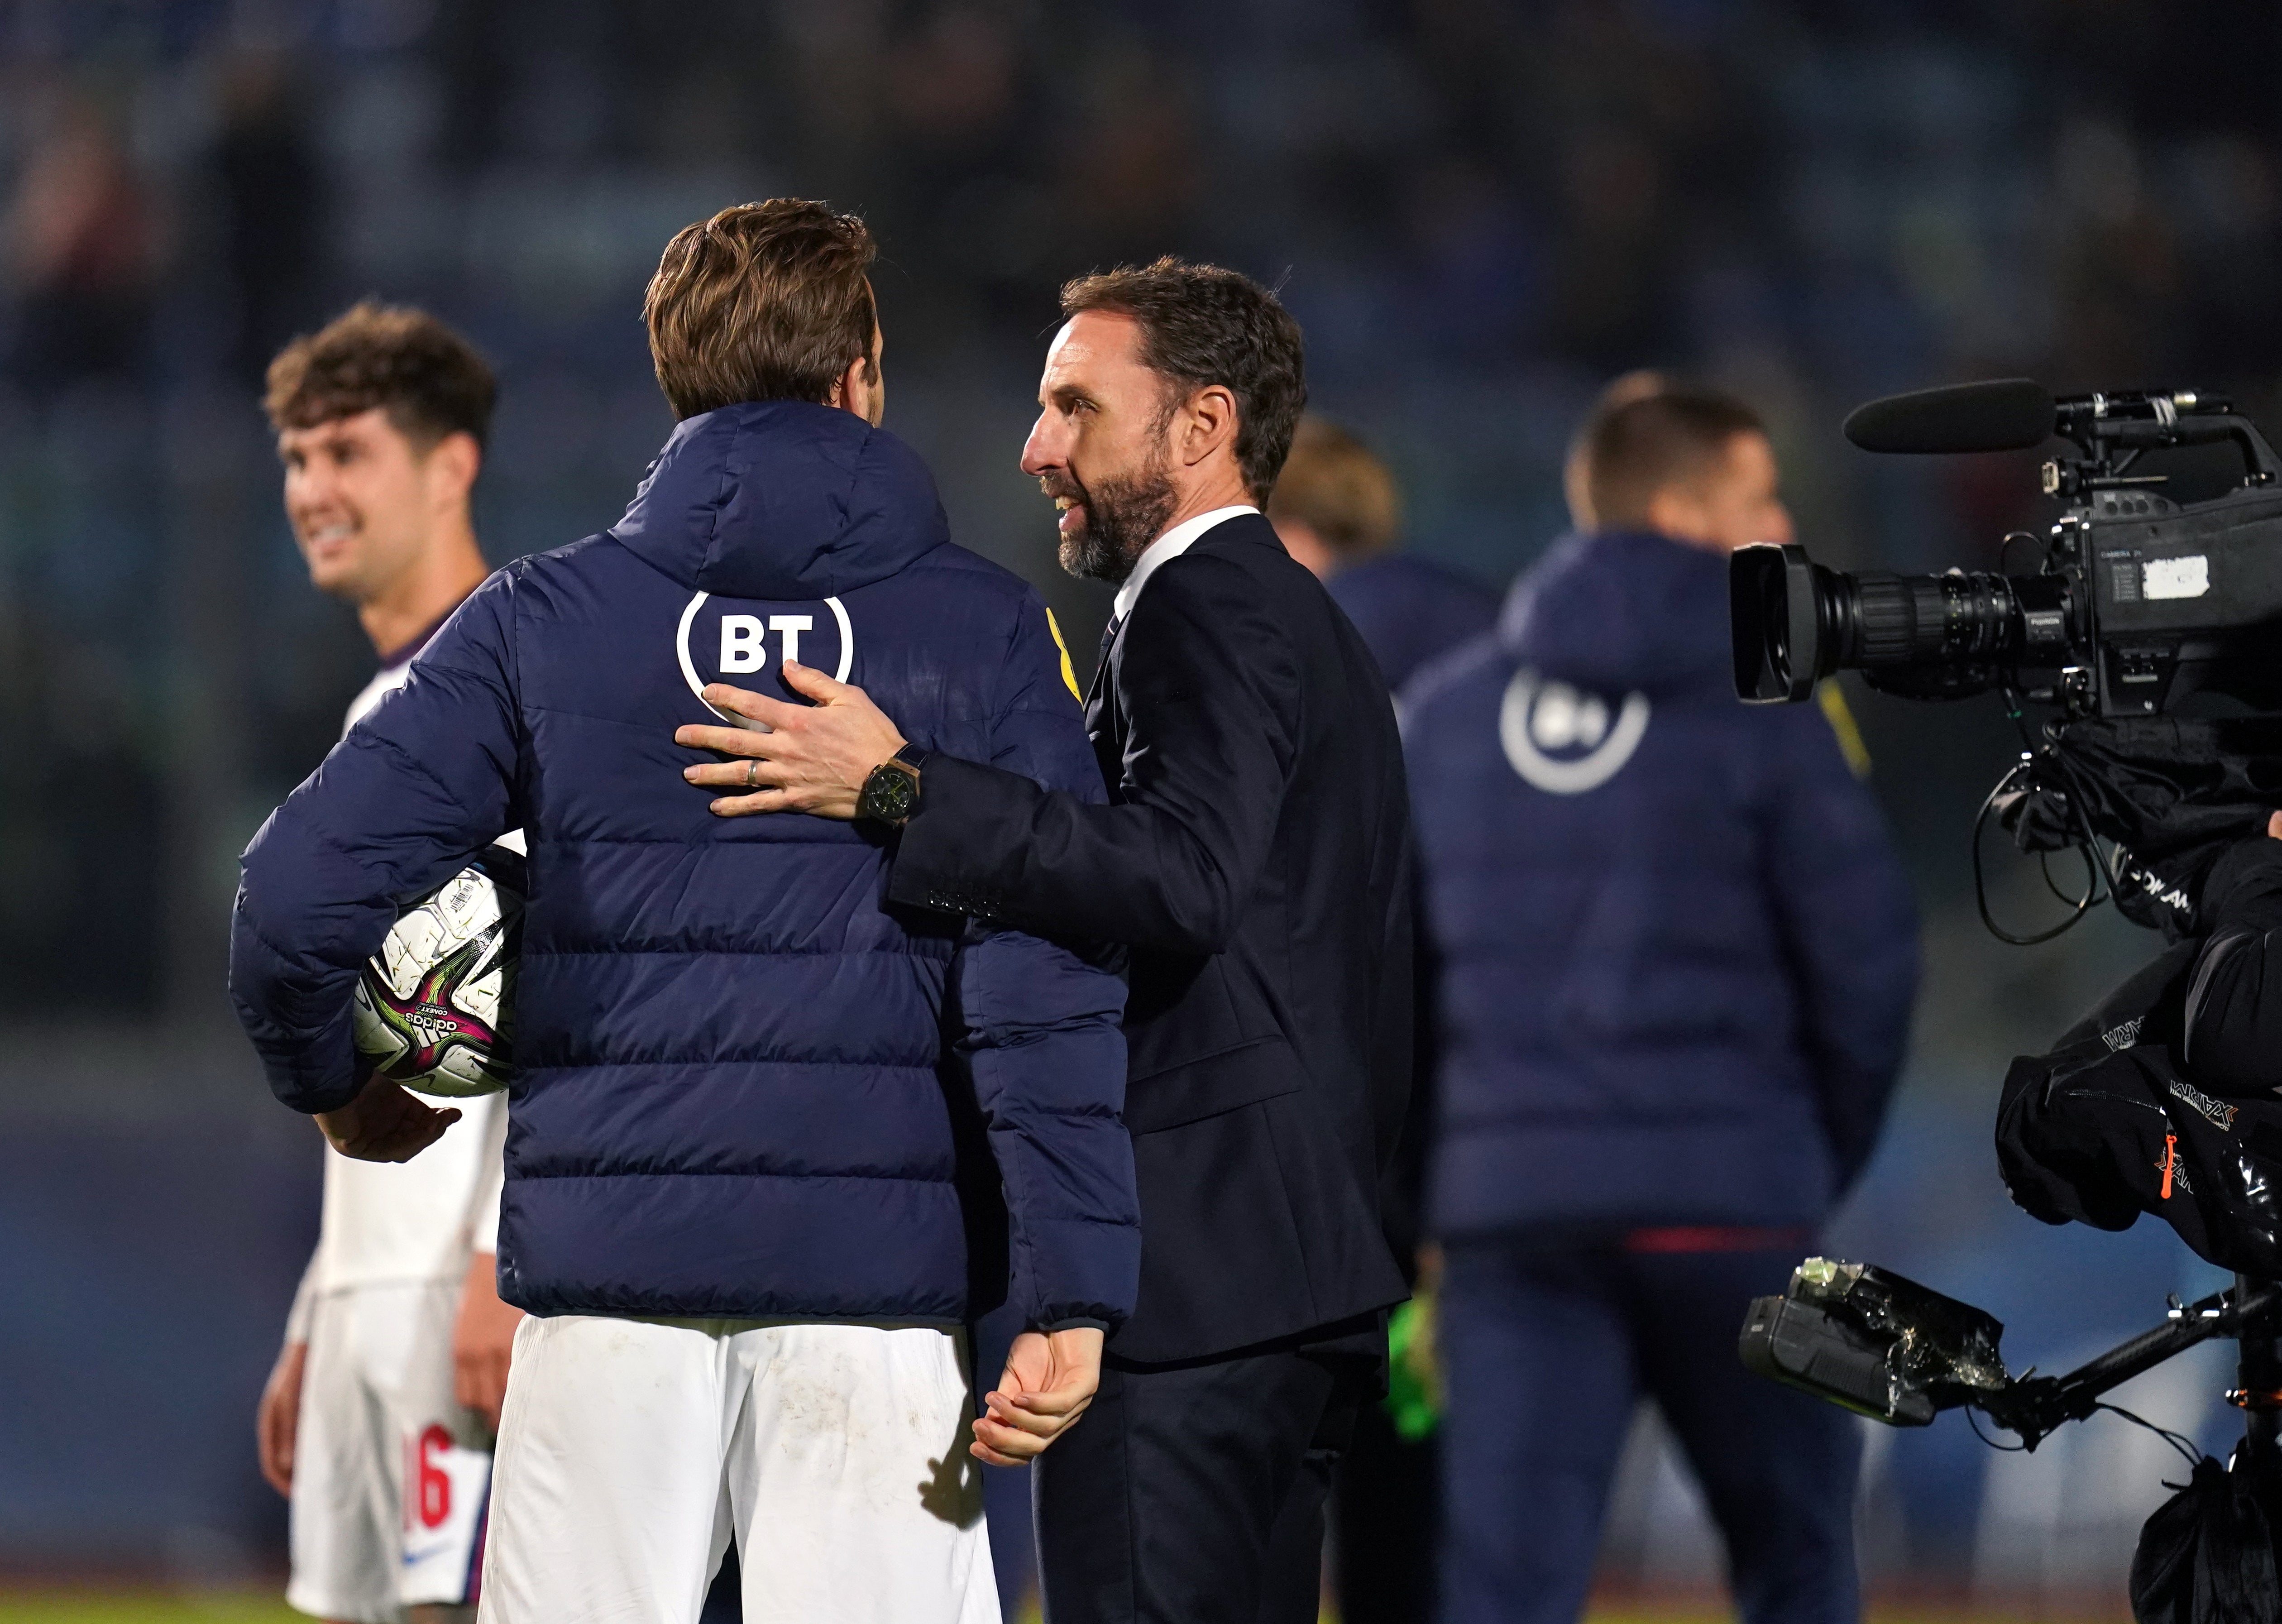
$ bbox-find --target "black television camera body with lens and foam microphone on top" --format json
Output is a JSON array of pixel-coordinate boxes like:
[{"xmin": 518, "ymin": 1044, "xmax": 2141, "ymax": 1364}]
[{"xmin": 1730, "ymin": 381, "xmax": 2282, "ymax": 719}]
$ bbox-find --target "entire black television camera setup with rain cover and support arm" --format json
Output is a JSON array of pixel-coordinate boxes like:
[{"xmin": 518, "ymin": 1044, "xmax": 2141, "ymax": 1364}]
[{"xmin": 1730, "ymin": 390, "xmax": 2282, "ymax": 1617}]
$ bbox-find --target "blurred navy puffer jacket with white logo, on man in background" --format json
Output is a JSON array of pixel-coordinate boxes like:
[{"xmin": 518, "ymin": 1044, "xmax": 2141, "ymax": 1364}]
[{"xmin": 1403, "ymin": 534, "xmax": 1917, "ymax": 1239}]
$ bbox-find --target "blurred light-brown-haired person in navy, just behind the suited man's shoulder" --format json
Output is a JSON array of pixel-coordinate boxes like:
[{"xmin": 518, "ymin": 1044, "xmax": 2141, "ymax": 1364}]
[{"xmin": 1267, "ymin": 415, "xmax": 1497, "ymax": 689}]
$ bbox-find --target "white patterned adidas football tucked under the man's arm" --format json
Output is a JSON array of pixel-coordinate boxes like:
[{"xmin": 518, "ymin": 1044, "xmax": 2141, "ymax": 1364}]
[{"xmin": 354, "ymin": 846, "xmax": 522, "ymax": 1097}]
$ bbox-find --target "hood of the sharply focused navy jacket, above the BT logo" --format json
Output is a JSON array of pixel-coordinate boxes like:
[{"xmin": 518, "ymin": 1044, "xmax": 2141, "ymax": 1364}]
[{"xmin": 609, "ymin": 402, "xmax": 952, "ymax": 600}]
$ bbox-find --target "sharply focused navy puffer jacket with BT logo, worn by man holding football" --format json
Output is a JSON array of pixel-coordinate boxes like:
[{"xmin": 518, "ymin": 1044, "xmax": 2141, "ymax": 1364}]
[{"xmin": 230, "ymin": 402, "xmax": 1139, "ymax": 1325}]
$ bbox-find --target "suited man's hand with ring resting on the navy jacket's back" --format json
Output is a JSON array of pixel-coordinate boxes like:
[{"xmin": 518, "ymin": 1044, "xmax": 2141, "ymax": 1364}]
[{"xmin": 673, "ymin": 659, "xmax": 904, "ymax": 819}]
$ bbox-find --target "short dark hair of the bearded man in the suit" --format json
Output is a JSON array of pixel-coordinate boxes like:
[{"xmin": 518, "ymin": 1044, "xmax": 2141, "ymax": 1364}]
[{"xmin": 1061, "ymin": 255, "xmax": 1307, "ymax": 502}]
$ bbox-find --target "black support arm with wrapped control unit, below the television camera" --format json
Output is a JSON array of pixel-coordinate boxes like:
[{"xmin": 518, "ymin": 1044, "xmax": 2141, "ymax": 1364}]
[{"xmin": 1739, "ymin": 1257, "xmax": 2282, "ymax": 1469}]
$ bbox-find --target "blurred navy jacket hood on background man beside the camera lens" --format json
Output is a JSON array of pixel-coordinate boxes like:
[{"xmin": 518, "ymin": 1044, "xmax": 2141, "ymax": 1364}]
[{"xmin": 1497, "ymin": 532, "xmax": 1734, "ymax": 694}]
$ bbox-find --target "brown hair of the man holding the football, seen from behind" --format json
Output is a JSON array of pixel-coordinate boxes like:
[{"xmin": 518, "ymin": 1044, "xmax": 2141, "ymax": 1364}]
[{"xmin": 641, "ymin": 198, "xmax": 879, "ymax": 417}]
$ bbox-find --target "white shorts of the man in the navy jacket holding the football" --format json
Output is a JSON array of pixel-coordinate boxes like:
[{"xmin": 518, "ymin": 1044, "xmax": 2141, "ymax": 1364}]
[{"xmin": 479, "ymin": 1316, "xmax": 1000, "ymax": 1624}]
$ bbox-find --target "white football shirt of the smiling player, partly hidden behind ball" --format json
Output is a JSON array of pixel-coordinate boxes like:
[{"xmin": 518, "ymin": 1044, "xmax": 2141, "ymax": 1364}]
[{"xmin": 297, "ymin": 620, "xmax": 522, "ymax": 1316}]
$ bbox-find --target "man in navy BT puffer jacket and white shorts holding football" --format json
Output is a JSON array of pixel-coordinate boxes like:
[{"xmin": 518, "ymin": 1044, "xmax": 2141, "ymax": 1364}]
[{"xmin": 233, "ymin": 203, "xmax": 1139, "ymax": 1624}]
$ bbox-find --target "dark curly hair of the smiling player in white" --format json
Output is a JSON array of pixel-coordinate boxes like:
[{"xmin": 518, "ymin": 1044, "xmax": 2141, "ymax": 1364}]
[{"xmin": 263, "ymin": 299, "xmax": 500, "ymax": 452}]
